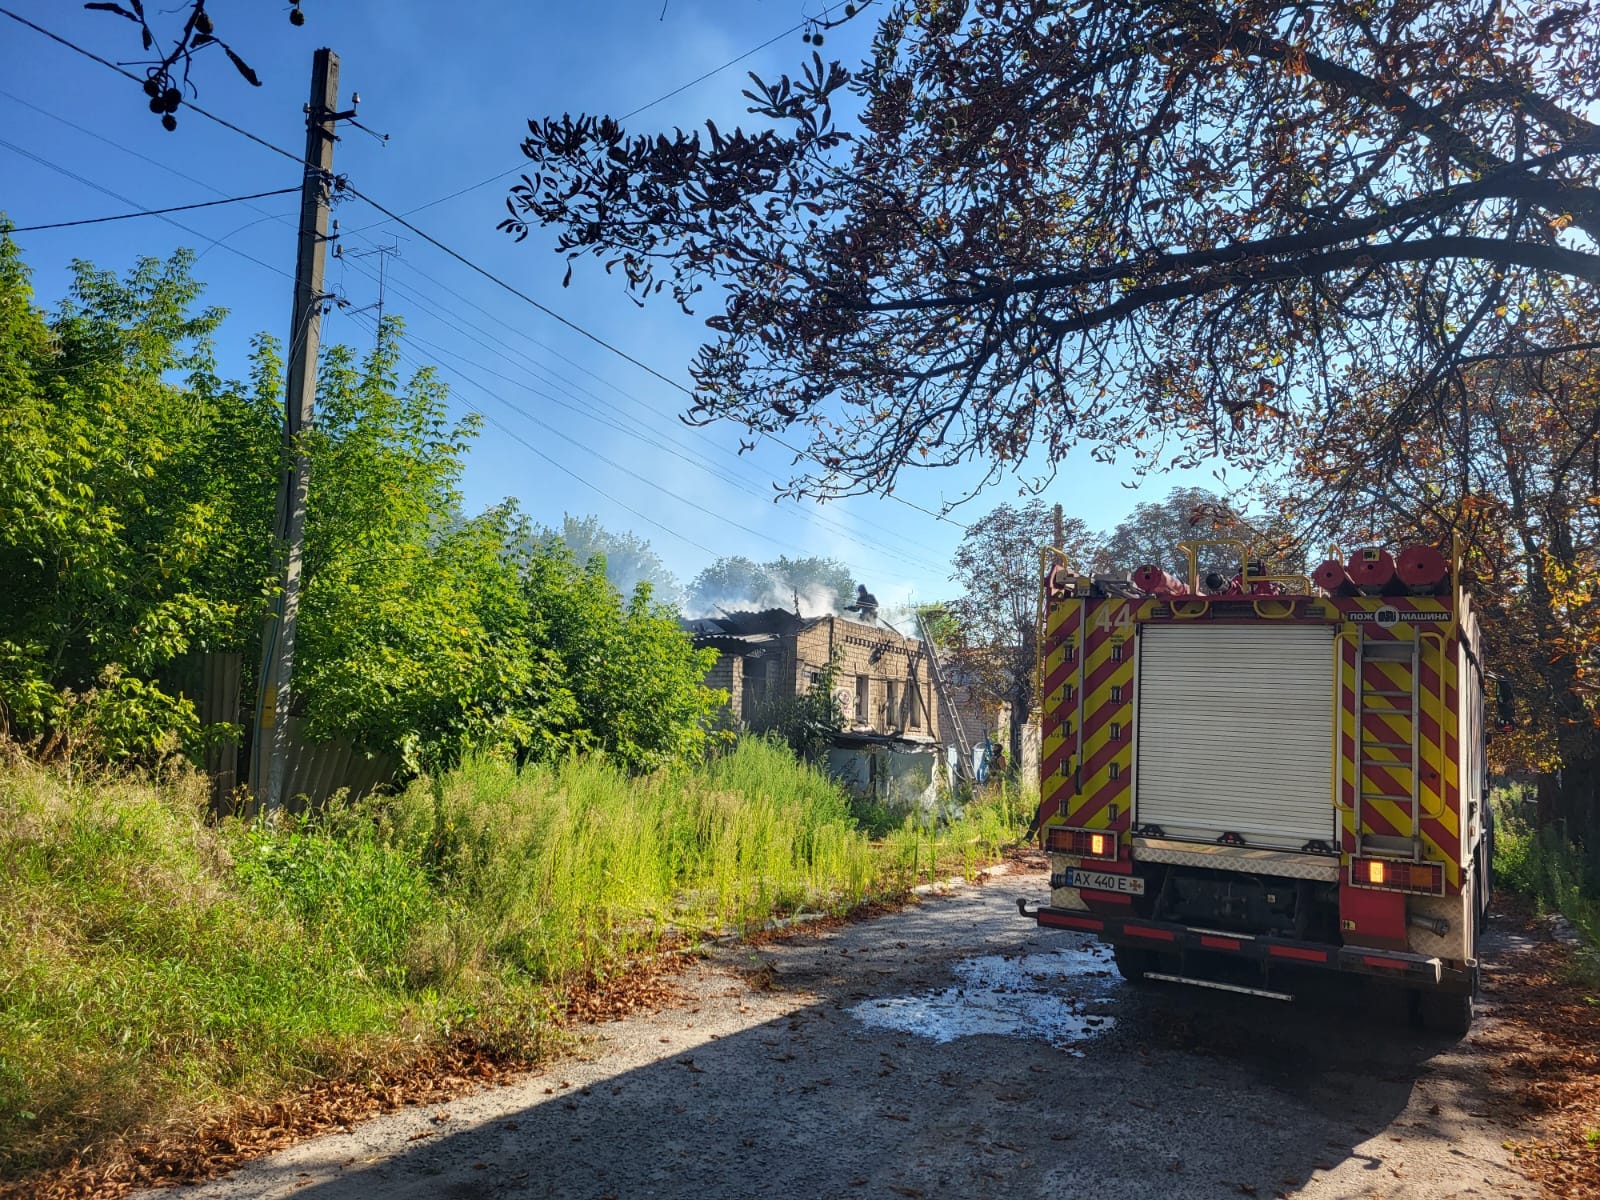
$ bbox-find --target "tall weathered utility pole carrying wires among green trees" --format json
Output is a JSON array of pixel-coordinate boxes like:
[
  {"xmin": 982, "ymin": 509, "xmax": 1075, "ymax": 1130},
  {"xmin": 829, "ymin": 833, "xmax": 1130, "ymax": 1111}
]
[{"xmin": 250, "ymin": 48, "xmax": 347, "ymax": 811}]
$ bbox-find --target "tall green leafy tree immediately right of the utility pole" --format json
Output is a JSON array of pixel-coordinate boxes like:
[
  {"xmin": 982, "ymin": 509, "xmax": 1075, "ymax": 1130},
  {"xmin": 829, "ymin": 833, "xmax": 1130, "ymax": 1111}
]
[{"xmin": 296, "ymin": 320, "xmax": 536, "ymax": 758}]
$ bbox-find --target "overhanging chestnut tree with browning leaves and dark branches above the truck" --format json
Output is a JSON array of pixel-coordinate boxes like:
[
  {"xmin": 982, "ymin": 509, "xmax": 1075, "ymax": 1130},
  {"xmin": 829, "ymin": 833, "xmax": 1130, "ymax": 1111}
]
[{"xmin": 501, "ymin": 0, "xmax": 1600, "ymax": 494}]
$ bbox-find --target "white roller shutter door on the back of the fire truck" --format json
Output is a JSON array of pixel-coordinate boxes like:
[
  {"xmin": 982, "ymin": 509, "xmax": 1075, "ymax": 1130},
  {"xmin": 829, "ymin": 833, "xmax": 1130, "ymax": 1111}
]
[{"xmin": 1134, "ymin": 624, "xmax": 1338, "ymax": 850}]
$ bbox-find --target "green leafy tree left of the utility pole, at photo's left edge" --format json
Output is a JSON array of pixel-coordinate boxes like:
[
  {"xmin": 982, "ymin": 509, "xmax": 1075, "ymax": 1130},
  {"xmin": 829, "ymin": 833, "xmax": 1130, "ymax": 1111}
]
[{"xmin": 0, "ymin": 235, "xmax": 277, "ymax": 757}]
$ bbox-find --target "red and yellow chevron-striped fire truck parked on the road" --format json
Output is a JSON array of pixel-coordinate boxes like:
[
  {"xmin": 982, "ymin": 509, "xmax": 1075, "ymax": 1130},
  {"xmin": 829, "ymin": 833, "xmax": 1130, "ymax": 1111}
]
[{"xmin": 1018, "ymin": 542, "xmax": 1493, "ymax": 1032}]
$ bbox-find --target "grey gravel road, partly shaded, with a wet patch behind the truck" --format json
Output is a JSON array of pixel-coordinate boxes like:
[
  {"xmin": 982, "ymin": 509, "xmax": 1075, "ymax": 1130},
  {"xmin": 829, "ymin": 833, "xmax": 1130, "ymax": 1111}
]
[{"xmin": 147, "ymin": 869, "xmax": 1536, "ymax": 1200}]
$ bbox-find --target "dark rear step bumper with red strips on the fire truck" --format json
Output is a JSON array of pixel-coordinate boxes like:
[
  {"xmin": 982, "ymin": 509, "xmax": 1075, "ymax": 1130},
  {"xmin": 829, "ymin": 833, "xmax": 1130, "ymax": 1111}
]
[{"xmin": 1016, "ymin": 896, "xmax": 1474, "ymax": 992}]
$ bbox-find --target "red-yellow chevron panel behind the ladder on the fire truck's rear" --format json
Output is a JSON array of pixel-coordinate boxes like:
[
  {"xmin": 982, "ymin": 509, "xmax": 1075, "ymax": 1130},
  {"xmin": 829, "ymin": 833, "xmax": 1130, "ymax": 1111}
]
[{"xmin": 1339, "ymin": 597, "xmax": 1461, "ymax": 890}]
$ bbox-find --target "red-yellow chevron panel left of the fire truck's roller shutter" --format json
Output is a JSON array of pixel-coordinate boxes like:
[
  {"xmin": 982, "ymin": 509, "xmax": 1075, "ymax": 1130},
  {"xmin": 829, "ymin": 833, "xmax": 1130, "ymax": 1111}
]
[{"xmin": 1040, "ymin": 598, "xmax": 1138, "ymax": 830}]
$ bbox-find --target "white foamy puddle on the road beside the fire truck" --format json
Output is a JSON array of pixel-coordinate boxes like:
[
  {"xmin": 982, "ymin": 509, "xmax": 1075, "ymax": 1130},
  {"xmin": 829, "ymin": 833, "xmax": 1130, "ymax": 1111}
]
[{"xmin": 850, "ymin": 944, "xmax": 1122, "ymax": 1053}]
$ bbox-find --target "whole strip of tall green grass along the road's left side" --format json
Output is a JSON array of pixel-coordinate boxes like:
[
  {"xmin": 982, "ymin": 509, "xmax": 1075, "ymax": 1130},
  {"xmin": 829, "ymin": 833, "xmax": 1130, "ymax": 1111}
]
[{"xmin": 0, "ymin": 739, "xmax": 1026, "ymax": 1176}]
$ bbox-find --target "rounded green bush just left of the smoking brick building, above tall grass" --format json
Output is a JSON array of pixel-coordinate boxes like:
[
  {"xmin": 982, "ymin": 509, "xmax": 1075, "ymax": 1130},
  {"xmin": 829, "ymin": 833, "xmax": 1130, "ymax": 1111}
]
[{"xmin": 523, "ymin": 544, "xmax": 726, "ymax": 770}]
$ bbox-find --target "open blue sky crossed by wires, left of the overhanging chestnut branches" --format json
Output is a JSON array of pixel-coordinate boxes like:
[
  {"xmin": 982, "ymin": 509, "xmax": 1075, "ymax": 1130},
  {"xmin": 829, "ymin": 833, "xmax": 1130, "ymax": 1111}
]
[{"xmin": 0, "ymin": 0, "xmax": 1214, "ymax": 603}]
